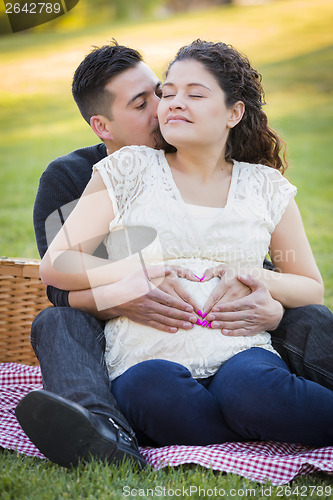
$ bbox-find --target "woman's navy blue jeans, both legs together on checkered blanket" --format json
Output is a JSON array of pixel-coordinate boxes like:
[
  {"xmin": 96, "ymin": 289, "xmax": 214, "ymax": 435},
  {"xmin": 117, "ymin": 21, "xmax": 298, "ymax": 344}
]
[{"xmin": 112, "ymin": 347, "xmax": 333, "ymax": 447}]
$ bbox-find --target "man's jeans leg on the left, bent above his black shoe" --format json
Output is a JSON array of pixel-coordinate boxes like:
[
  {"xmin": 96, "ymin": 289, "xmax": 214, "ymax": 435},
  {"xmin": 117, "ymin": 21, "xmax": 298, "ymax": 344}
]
[{"xmin": 31, "ymin": 307, "xmax": 131, "ymax": 430}]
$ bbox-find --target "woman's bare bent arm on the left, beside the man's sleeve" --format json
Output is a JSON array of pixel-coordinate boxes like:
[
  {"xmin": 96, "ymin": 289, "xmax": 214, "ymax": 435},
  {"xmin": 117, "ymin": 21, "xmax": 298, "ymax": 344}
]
[{"xmin": 40, "ymin": 172, "xmax": 139, "ymax": 290}]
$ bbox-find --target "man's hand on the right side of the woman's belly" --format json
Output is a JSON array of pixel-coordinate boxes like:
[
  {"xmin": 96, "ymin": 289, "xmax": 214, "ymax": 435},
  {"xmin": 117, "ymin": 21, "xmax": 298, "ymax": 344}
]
[{"xmin": 205, "ymin": 275, "xmax": 284, "ymax": 336}]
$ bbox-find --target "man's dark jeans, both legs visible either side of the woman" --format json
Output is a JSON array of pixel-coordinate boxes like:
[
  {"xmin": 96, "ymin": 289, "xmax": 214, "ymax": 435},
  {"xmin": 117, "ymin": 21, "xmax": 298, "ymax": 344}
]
[{"xmin": 31, "ymin": 306, "xmax": 333, "ymax": 436}]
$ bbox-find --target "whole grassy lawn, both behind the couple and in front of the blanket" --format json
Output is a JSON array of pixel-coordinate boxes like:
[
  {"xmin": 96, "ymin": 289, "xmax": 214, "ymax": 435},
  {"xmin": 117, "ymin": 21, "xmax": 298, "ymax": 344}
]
[{"xmin": 0, "ymin": 0, "xmax": 333, "ymax": 492}]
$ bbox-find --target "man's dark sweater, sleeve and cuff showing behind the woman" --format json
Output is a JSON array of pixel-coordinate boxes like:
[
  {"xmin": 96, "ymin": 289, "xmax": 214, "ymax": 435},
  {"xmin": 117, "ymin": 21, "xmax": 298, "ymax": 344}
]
[{"xmin": 33, "ymin": 144, "xmax": 106, "ymax": 306}]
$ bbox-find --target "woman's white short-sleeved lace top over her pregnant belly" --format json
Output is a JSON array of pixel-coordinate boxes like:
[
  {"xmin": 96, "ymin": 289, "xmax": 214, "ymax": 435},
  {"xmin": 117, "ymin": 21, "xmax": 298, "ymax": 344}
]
[{"xmin": 94, "ymin": 146, "xmax": 296, "ymax": 380}]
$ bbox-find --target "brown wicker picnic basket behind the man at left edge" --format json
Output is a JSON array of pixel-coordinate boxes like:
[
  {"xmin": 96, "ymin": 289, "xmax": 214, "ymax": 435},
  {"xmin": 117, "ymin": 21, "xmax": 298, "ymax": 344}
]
[{"xmin": 0, "ymin": 257, "xmax": 51, "ymax": 365}]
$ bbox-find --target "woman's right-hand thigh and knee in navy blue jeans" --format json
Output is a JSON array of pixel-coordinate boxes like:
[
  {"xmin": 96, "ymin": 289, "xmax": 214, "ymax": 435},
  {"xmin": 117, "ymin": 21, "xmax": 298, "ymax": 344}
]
[{"xmin": 209, "ymin": 348, "xmax": 333, "ymax": 447}]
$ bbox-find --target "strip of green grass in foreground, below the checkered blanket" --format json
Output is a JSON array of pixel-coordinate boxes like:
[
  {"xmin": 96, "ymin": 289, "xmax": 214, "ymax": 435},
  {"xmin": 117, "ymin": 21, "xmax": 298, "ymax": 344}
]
[{"xmin": 0, "ymin": 450, "xmax": 333, "ymax": 500}]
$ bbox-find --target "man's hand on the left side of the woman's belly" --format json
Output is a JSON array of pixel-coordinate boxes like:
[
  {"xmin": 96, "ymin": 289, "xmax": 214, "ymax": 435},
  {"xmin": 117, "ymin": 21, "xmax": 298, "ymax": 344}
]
[{"xmin": 98, "ymin": 266, "xmax": 199, "ymax": 333}]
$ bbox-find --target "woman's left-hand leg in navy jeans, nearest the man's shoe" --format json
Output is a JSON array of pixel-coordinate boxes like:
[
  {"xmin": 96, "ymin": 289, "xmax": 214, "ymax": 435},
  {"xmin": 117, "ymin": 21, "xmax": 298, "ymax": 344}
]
[{"xmin": 112, "ymin": 359, "xmax": 242, "ymax": 446}]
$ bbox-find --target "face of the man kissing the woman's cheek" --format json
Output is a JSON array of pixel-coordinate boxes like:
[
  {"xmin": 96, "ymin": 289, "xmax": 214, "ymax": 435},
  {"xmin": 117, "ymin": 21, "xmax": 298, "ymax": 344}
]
[{"xmin": 105, "ymin": 62, "xmax": 163, "ymax": 153}]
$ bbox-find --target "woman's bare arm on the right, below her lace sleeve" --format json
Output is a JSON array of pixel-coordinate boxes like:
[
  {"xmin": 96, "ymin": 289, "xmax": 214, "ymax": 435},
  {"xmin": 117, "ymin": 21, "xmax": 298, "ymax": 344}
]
[{"xmin": 252, "ymin": 200, "xmax": 324, "ymax": 308}]
